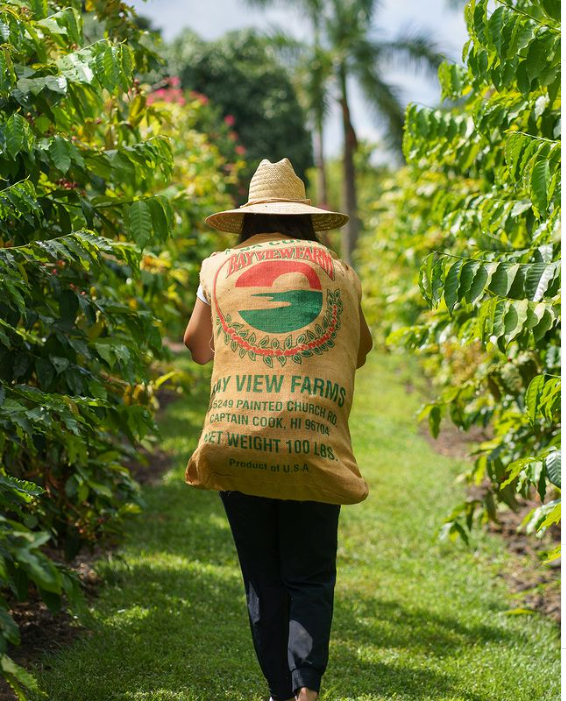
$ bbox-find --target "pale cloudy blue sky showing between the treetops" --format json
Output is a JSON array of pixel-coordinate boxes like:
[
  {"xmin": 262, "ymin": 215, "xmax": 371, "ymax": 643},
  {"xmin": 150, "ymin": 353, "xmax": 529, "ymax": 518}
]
[{"xmin": 130, "ymin": 0, "xmax": 467, "ymax": 160}]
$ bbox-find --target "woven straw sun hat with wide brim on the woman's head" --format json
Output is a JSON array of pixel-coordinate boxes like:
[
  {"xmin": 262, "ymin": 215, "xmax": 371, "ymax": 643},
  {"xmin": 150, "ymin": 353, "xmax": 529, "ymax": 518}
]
[{"xmin": 205, "ymin": 158, "xmax": 349, "ymax": 234}]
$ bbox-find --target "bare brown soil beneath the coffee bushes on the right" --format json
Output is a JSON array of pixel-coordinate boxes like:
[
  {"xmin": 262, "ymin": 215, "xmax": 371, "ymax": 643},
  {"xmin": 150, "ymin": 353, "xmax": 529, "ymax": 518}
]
[{"xmin": 422, "ymin": 410, "xmax": 561, "ymax": 623}]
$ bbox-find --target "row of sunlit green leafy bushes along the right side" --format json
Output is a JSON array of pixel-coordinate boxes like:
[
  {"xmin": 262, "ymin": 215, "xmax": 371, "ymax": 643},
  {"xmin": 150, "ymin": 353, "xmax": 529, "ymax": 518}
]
[{"xmin": 360, "ymin": 0, "xmax": 560, "ymax": 557}]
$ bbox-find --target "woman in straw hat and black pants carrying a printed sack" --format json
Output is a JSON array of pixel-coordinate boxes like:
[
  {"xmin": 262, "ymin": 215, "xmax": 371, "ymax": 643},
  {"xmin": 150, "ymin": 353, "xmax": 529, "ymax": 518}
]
[{"xmin": 184, "ymin": 158, "xmax": 372, "ymax": 701}]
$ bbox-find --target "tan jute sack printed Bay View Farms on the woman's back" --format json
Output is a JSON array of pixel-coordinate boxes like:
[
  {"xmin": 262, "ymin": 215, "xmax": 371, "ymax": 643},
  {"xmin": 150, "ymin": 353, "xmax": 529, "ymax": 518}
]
[{"xmin": 185, "ymin": 233, "xmax": 368, "ymax": 504}]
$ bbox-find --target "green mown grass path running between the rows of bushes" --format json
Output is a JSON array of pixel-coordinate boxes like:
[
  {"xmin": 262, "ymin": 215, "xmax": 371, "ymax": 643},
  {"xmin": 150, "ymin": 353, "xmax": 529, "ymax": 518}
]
[{"xmin": 30, "ymin": 353, "xmax": 559, "ymax": 701}]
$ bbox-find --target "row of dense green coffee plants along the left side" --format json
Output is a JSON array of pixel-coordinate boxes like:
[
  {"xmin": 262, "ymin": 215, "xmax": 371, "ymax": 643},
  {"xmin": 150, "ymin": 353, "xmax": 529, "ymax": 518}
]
[{"xmin": 0, "ymin": 0, "xmax": 242, "ymax": 698}]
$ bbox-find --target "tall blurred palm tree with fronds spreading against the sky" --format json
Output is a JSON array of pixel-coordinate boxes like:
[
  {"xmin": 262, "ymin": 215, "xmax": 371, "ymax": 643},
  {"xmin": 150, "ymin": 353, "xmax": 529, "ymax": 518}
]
[{"xmin": 242, "ymin": 0, "xmax": 444, "ymax": 264}]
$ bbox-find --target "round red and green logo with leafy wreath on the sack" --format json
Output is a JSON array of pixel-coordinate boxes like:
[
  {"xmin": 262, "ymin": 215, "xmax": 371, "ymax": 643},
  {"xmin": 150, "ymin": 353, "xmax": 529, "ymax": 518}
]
[{"xmin": 213, "ymin": 252, "xmax": 343, "ymax": 367}]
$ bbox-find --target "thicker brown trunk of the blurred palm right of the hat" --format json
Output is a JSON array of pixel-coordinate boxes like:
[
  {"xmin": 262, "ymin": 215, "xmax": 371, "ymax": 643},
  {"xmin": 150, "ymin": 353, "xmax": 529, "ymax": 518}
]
[{"xmin": 340, "ymin": 66, "xmax": 360, "ymax": 265}]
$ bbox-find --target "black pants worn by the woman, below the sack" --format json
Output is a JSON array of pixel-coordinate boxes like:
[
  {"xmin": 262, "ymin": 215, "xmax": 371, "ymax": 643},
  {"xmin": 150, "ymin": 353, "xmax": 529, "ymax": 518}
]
[{"xmin": 219, "ymin": 491, "xmax": 340, "ymax": 701}]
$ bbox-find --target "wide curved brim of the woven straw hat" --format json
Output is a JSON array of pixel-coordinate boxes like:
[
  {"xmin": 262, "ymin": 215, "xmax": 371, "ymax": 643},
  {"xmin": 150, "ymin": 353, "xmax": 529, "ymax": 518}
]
[{"xmin": 205, "ymin": 202, "xmax": 350, "ymax": 234}]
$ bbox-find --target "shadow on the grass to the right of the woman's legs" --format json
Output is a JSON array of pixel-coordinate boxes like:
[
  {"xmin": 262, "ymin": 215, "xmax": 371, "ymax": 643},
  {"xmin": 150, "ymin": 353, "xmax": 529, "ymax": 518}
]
[{"xmin": 324, "ymin": 592, "xmax": 516, "ymax": 701}]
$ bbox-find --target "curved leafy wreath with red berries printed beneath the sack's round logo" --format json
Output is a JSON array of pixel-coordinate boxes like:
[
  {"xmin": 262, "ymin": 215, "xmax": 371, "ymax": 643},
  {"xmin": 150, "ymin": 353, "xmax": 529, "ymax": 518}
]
[{"xmin": 215, "ymin": 290, "xmax": 344, "ymax": 368}]
